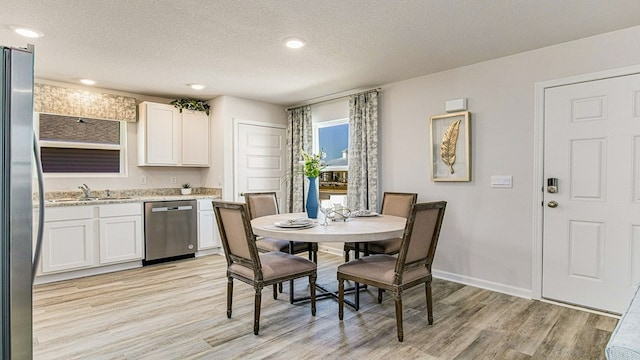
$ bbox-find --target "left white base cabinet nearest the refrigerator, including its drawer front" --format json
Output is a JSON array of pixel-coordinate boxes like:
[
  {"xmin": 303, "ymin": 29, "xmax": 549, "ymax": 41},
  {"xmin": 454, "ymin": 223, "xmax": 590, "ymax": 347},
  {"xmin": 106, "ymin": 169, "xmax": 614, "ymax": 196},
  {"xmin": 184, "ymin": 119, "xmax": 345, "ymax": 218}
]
[{"xmin": 41, "ymin": 206, "xmax": 96, "ymax": 274}]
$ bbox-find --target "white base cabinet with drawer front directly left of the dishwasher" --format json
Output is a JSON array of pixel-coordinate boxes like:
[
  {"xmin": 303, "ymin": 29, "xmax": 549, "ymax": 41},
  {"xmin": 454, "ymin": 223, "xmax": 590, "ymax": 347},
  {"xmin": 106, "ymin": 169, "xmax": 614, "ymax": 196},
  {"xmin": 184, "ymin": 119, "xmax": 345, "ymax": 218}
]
[{"xmin": 99, "ymin": 203, "xmax": 143, "ymax": 265}]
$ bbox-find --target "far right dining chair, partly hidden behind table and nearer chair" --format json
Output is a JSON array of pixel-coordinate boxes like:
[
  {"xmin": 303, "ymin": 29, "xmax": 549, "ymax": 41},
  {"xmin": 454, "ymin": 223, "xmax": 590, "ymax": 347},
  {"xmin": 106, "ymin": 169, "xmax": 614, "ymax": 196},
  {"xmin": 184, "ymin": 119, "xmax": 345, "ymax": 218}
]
[{"xmin": 344, "ymin": 192, "xmax": 418, "ymax": 262}]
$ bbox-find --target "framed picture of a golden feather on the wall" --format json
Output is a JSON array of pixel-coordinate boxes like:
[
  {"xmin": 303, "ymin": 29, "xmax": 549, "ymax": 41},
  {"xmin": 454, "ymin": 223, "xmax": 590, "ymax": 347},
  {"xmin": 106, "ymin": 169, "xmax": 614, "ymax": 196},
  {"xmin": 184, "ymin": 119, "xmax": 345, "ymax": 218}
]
[{"xmin": 429, "ymin": 111, "xmax": 471, "ymax": 181}]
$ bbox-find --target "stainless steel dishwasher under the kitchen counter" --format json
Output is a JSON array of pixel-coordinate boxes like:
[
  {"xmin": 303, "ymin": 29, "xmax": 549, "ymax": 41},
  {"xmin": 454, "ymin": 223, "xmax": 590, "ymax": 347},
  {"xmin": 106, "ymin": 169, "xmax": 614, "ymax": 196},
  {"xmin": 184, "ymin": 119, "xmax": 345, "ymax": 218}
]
[{"xmin": 143, "ymin": 200, "xmax": 198, "ymax": 265}]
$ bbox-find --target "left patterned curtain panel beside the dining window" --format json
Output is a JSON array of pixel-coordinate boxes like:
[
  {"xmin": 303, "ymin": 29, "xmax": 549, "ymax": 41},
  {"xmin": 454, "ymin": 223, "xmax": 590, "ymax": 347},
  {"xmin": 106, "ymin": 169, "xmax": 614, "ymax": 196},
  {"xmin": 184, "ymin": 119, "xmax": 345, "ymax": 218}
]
[{"xmin": 285, "ymin": 106, "xmax": 313, "ymax": 212}]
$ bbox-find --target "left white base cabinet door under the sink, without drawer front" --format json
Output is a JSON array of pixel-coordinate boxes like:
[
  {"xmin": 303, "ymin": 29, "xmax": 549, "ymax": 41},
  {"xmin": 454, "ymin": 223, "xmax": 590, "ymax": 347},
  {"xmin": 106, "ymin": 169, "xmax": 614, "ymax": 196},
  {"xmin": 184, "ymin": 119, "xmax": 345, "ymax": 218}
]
[{"xmin": 42, "ymin": 219, "xmax": 95, "ymax": 274}]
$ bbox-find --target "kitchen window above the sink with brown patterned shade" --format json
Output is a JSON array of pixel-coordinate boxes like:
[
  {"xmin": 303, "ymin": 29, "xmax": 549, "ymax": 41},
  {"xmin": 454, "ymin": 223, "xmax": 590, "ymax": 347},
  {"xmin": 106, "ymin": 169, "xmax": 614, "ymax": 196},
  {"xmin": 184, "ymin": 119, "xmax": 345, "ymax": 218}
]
[{"xmin": 36, "ymin": 113, "xmax": 126, "ymax": 175}]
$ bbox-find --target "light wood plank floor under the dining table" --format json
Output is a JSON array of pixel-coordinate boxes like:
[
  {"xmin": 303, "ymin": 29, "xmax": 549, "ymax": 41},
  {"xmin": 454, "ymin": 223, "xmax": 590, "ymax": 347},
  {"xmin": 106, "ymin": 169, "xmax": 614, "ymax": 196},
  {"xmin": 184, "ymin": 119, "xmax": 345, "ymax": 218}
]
[{"xmin": 33, "ymin": 253, "xmax": 617, "ymax": 360}]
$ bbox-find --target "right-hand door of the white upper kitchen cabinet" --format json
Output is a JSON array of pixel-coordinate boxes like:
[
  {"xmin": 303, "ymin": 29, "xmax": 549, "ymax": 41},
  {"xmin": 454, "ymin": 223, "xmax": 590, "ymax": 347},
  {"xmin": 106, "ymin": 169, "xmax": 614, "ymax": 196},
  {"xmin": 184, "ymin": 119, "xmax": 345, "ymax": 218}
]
[{"xmin": 182, "ymin": 110, "xmax": 209, "ymax": 166}]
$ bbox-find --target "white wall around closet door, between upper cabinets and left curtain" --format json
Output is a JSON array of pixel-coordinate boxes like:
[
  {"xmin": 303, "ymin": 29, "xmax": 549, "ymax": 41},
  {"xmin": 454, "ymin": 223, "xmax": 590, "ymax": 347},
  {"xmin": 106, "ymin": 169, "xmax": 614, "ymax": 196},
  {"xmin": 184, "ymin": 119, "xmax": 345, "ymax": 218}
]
[{"xmin": 205, "ymin": 96, "xmax": 287, "ymax": 200}]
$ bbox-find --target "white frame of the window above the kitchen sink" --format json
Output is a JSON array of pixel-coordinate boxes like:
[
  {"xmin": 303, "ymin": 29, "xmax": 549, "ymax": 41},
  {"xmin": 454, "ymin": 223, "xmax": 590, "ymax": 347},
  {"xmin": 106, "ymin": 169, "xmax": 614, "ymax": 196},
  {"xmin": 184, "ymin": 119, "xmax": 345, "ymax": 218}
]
[{"xmin": 33, "ymin": 112, "xmax": 128, "ymax": 178}]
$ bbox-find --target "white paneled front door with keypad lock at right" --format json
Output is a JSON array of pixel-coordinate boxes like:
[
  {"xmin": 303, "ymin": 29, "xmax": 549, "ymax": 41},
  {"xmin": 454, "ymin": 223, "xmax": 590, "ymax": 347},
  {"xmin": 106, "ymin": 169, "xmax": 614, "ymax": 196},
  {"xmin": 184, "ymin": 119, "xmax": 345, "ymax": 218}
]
[{"xmin": 542, "ymin": 74, "xmax": 640, "ymax": 313}]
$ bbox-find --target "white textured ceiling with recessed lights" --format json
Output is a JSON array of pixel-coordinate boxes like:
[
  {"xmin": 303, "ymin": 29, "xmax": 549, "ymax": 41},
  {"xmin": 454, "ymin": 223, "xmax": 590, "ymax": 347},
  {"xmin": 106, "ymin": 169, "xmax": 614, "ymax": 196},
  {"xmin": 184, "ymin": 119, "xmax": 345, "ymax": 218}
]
[{"xmin": 0, "ymin": 0, "xmax": 640, "ymax": 105}]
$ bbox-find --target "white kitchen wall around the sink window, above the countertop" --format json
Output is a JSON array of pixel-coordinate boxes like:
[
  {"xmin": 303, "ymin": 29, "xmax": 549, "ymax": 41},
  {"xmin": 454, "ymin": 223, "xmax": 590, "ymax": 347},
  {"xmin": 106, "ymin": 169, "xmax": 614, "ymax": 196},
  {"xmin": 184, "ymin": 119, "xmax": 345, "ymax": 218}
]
[{"xmin": 34, "ymin": 79, "xmax": 206, "ymax": 192}]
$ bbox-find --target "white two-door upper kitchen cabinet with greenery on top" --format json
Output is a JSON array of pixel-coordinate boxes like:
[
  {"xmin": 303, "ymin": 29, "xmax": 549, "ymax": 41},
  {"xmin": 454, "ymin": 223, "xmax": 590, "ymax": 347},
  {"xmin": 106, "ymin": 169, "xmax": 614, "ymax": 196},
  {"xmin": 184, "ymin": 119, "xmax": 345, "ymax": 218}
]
[{"xmin": 138, "ymin": 102, "xmax": 209, "ymax": 167}]
